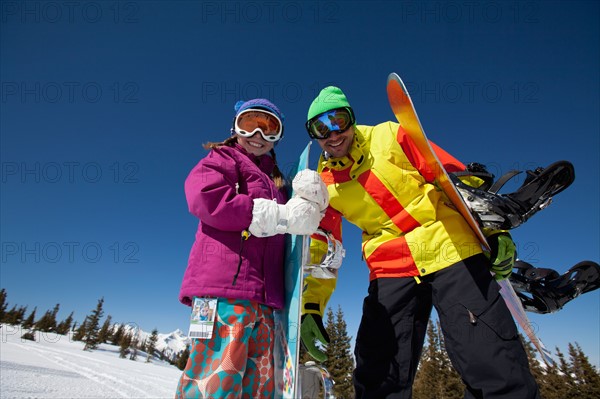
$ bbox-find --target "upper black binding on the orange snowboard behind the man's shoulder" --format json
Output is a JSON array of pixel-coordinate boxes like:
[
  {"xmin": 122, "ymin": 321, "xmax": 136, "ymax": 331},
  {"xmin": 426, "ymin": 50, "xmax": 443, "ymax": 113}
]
[{"xmin": 451, "ymin": 161, "xmax": 575, "ymax": 230}]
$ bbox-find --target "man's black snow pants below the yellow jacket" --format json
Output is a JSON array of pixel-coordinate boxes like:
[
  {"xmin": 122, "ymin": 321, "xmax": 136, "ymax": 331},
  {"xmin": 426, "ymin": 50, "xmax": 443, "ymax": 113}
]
[{"xmin": 354, "ymin": 255, "xmax": 540, "ymax": 399}]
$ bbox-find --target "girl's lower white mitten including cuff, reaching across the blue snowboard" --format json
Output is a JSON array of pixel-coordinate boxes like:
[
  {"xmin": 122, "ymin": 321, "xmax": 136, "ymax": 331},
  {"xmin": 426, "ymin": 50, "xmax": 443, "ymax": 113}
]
[{"xmin": 248, "ymin": 197, "xmax": 322, "ymax": 237}]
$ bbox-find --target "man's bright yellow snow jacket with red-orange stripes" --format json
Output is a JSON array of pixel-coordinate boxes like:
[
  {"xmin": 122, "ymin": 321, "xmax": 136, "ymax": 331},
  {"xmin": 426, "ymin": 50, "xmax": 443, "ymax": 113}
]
[{"xmin": 303, "ymin": 122, "xmax": 482, "ymax": 314}]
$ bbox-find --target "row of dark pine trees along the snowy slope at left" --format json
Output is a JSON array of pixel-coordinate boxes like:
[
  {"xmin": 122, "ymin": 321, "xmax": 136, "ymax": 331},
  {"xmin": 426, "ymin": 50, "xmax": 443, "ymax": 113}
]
[{"xmin": 0, "ymin": 289, "xmax": 189, "ymax": 370}]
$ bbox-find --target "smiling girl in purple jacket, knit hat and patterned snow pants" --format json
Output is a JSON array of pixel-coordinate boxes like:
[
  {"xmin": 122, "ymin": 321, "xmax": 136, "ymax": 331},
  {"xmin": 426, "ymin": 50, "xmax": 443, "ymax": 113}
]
[{"xmin": 176, "ymin": 99, "xmax": 328, "ymax": 398}]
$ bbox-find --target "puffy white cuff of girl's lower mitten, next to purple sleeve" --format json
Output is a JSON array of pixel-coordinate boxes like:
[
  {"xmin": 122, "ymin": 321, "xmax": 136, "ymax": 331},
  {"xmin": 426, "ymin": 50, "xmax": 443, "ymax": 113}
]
[{"xmin": 248, "ymin": 198, "xmax": 287, "ymax": 237}]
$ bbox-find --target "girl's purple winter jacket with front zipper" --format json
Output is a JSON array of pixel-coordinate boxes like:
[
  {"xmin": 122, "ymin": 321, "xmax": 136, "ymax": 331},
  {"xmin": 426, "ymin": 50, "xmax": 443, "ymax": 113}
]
[{"xmin": 179, "ymin": 144, "xmax": 287, "ymax": 309}]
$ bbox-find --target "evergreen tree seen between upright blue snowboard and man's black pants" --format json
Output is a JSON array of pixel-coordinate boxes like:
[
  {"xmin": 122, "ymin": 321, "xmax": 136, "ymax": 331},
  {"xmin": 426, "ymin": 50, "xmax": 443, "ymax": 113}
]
[{"xmin": 324, "ymin": 306, "xmax": 354, "ymax": 398}]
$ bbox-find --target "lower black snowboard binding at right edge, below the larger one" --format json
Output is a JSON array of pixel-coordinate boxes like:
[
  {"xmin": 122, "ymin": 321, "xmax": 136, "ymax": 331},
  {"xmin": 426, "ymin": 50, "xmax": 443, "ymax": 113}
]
[{"xmin": 509, "ymin": 260, "xmax": 600, "ymax": 314}]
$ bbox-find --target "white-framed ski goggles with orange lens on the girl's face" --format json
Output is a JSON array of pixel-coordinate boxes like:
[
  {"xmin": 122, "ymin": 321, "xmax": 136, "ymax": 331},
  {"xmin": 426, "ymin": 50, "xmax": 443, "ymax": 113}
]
[{"xmin": 232, "ymin": 108, "xmax": 283, "ymax": 143}]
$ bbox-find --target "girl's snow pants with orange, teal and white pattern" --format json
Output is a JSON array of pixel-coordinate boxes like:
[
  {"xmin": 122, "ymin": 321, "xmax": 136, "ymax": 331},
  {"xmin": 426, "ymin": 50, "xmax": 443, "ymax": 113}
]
[{"xmin": 175, "ymin": 298, "xmax": 275, "ymax": 399}]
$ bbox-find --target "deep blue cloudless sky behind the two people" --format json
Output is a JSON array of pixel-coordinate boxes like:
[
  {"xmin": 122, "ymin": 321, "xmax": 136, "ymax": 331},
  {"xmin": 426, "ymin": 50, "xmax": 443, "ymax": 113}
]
[{"xmin": 0, "ymin": 1, "xmax": 600, "ymax": 365}]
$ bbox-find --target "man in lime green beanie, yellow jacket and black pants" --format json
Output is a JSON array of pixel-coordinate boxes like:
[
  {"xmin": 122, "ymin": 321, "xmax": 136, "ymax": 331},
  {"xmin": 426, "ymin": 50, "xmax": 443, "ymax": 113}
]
[{"xmin": 301, "ymin": 86, "xmax": 539, "ymax": 399}]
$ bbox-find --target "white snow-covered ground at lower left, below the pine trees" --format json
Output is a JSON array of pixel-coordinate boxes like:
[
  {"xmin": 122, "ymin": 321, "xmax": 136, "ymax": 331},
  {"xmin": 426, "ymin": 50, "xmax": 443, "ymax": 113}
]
[{"xmin": 0, "ymin": 325, "xmax": 181, "ymax": 399}]
